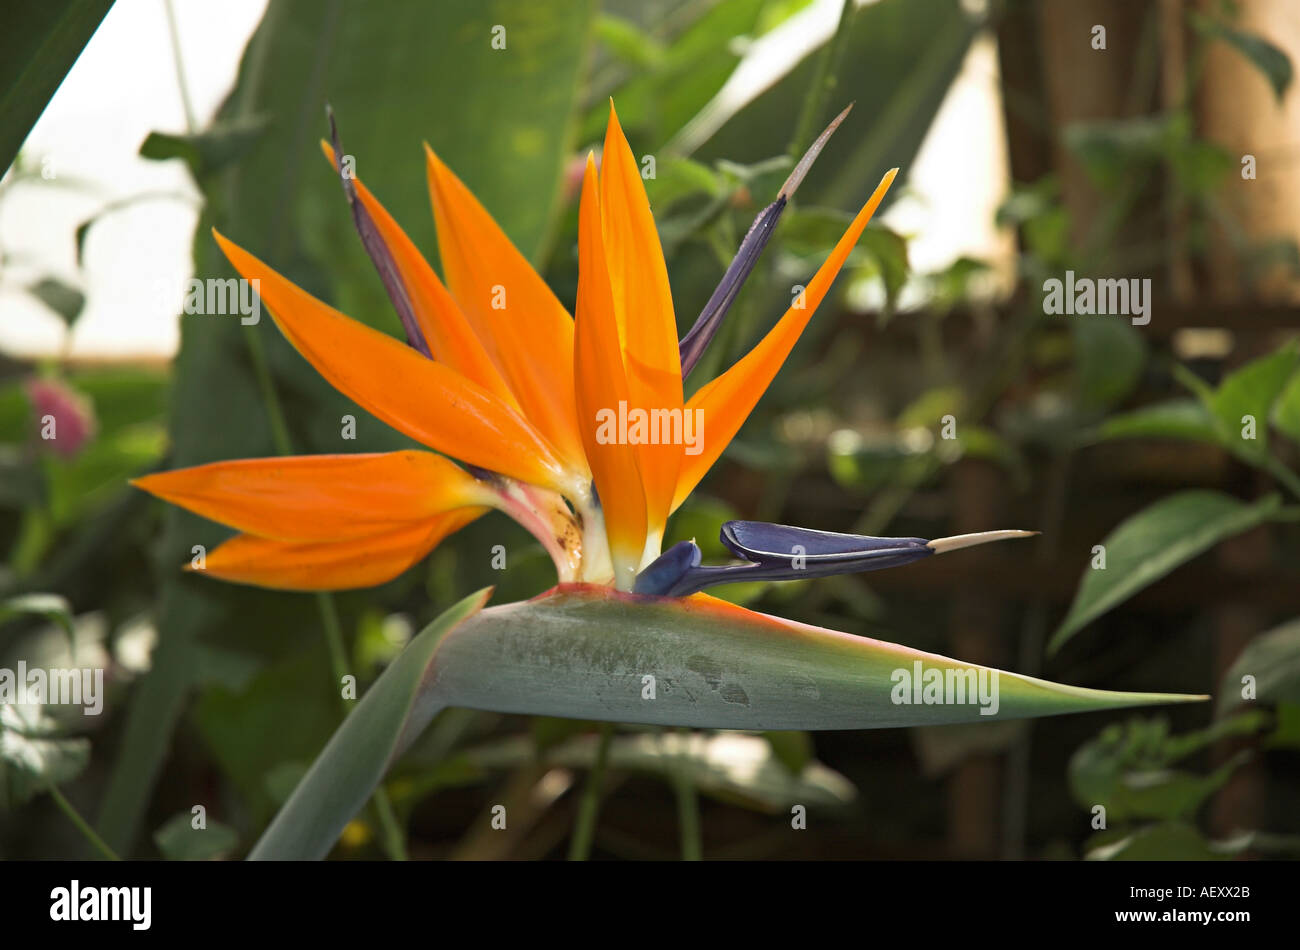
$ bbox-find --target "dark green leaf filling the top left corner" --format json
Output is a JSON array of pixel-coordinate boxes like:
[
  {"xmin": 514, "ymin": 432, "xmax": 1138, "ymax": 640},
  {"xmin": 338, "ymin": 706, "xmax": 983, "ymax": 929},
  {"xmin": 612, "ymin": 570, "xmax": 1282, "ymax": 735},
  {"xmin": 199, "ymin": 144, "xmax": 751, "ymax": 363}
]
[{"xmin": 0, "ymin": 0, "xmax": 113, "ymax": 174}]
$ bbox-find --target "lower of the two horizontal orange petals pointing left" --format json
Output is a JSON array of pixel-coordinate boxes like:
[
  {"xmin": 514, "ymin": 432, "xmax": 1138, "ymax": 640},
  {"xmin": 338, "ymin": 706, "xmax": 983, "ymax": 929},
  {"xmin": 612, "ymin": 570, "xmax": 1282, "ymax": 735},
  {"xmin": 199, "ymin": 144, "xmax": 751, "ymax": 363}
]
[{"xmin": 197, "ymin": 508, "xmax": 488, "ymax": 590}]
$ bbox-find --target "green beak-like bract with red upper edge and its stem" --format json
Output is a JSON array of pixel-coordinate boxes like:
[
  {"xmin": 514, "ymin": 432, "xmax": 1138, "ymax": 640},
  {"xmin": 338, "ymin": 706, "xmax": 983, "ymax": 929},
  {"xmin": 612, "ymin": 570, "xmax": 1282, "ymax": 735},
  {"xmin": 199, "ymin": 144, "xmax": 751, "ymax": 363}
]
[{"xmin": 251, "ymin": 586, "xmax": 1205, "ymax": 859}]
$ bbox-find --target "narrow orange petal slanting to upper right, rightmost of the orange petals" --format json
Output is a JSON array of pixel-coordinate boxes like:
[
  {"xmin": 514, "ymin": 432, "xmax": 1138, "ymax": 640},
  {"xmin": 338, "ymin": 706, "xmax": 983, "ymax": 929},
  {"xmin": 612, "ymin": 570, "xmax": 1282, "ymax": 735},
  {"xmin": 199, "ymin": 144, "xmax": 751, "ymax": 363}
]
[{"xmin": 672, "ymin": 169, "xmax": 898, "ymax": 509}]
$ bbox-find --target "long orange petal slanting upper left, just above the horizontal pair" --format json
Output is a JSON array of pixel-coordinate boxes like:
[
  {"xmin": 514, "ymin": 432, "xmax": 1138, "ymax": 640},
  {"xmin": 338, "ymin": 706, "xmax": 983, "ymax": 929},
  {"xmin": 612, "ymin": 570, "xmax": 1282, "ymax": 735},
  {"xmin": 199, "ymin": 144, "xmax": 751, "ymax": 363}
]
[{"xmin": 213, "ymin": 230, "xmax": 572, "ymax": 499}]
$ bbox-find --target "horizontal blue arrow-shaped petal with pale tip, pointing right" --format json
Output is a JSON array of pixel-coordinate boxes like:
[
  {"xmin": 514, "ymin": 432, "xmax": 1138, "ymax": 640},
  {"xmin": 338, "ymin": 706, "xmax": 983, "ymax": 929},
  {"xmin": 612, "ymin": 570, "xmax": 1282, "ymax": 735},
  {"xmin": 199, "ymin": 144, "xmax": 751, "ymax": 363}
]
[{"xmin": 634, "ymin": 521, "xmax": 1036, "ymax": 597}]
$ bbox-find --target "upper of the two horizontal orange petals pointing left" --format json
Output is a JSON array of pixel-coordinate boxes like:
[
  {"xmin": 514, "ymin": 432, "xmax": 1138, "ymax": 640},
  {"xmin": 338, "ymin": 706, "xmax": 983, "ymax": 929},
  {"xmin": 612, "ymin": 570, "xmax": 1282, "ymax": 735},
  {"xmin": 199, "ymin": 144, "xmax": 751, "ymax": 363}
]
[{"xmin": 131, "ymin": 450, "xmax": 485, "ymax": 541}]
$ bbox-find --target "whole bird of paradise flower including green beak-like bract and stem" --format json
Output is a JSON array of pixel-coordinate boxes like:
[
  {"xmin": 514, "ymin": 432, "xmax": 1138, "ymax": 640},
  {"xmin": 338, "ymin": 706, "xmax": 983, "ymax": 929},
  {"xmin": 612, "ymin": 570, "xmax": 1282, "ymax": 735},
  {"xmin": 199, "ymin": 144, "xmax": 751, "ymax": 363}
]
[{"xmin": 135, "ymin": 103, "xmax": 1200, "ymax": 855}]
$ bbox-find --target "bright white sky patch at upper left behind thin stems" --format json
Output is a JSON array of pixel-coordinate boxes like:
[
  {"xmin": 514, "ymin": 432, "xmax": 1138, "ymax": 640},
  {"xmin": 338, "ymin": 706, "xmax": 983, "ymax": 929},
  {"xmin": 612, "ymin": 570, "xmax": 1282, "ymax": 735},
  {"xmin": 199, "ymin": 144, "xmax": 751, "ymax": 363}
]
[{"xmin": 0, "ymin": 0, "xmax": 267, "ymax": 359}]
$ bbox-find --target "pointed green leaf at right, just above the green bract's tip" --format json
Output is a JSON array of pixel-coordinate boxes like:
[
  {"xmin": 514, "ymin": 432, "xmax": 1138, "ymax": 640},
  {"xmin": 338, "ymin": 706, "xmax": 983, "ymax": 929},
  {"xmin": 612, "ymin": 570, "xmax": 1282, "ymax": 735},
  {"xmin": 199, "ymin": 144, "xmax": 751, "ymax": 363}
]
[{"xmin": 1048, "ymin": 491, "xmax": 1282, "ymax": 652}]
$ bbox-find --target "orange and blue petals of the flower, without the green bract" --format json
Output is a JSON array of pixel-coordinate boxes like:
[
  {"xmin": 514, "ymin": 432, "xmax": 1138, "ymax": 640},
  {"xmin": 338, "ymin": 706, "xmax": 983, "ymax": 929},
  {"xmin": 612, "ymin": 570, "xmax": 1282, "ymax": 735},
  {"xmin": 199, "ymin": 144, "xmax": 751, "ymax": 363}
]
[{"xmin": 135, "ymin": 107, "xmax": 1013, "ymax": 595}]
